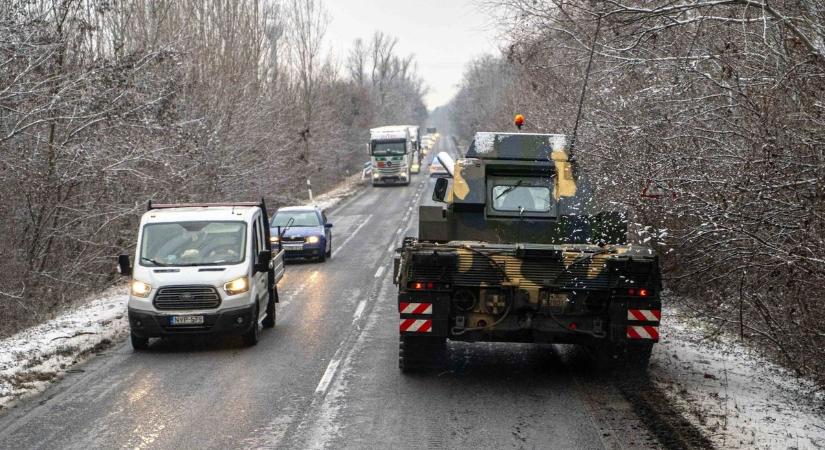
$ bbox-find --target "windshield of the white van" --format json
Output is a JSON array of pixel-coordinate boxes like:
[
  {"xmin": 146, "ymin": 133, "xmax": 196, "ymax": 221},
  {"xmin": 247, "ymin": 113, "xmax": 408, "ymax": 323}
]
[{"xmin": 139, "ymin": 221, "xmax": 246, "ymax": 266}]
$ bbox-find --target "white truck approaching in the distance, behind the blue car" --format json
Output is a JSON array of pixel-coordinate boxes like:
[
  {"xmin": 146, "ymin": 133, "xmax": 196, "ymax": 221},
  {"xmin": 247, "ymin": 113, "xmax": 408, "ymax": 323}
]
[{"xmin": 367, "ymin": 125, "xmax": 412, "ymax": 186}]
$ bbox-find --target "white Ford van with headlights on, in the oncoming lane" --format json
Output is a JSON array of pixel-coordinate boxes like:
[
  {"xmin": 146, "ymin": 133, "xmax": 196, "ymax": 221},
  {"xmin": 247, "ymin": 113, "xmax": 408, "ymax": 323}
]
[{"xmin": 118, "ymin": 202, "xmax": 284, "ymax": 350}]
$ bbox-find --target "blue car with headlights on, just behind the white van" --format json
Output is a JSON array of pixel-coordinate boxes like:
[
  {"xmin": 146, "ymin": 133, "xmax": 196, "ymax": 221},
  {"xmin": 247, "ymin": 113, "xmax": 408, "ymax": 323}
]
[{"xmin": 269, "ymin": 206, "xmax": 332, "ymax": 262}]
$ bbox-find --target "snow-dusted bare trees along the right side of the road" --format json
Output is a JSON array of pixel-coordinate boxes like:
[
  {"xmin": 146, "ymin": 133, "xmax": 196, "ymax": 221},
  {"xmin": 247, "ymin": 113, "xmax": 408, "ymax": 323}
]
[{"xmin": 452, "ymin": 0, "xmax": 825, "ymax": 382}]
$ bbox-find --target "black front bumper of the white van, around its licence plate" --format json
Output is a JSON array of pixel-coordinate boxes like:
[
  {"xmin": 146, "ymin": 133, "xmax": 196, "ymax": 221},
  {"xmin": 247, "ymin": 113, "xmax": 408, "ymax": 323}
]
[{"xmin": 129, "ymin": 305, "xmax": 255, "ymax": 338}]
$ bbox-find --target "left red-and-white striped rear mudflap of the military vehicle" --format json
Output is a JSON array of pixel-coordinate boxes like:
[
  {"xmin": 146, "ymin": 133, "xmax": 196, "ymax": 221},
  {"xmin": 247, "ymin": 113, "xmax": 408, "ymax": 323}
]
[{"xmin": 398, "ymin": 293, "xmax": 450, "ymax": 336}]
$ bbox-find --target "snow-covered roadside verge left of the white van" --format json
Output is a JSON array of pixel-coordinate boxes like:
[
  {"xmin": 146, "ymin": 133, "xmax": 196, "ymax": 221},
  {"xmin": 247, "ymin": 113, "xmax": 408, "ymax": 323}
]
[{"xmin": 0, "ymin": 284, "xmax": 128, "ymax": 410}]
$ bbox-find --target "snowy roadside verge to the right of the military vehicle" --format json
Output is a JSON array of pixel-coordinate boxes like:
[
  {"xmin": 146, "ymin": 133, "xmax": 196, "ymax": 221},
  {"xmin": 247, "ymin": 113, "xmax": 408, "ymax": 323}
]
[{"xmin": 650, "ymin": 302, "xmax": 825, "ymax": 449}]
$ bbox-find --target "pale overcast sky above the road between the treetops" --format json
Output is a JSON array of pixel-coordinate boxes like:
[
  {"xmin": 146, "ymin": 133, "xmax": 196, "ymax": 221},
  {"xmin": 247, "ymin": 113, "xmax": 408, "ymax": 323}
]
[{"xmin": 324, "ymin": 0, "xmax": 498, "ymax": 109}]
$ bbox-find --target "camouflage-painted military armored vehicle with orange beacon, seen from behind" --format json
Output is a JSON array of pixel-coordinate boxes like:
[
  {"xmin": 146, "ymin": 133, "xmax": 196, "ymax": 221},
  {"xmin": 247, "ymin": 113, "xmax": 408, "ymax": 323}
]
[{"xmin": 394, "ymin": 133, "xmax": 661, "ymax": 371}]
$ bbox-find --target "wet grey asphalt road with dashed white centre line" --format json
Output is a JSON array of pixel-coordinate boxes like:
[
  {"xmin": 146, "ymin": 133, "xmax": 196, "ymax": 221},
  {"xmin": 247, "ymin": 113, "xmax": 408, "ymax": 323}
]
[{"xmin": 0, "ymin": 136, "xmax": 660, "ymax": 449}]
